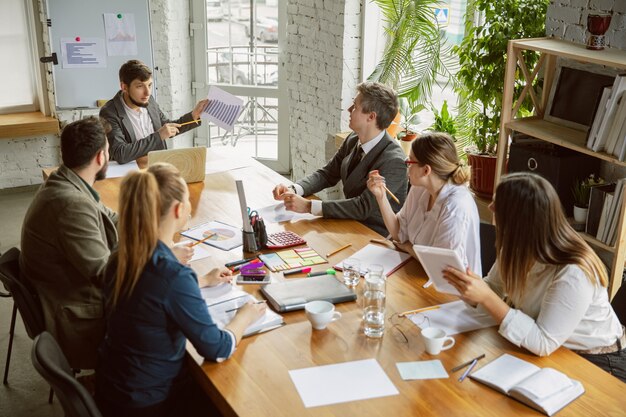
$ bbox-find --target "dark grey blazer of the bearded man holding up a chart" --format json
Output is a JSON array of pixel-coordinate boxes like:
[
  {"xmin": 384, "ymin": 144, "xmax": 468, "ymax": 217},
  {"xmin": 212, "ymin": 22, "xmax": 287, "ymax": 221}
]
[{"xmin": 100, "ymin": 91, "xmax": 200, "ymax": 164}]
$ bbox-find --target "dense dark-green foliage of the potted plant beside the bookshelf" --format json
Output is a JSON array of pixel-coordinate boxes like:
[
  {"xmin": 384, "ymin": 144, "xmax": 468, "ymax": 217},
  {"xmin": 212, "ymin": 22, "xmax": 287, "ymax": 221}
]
[{"xmin": 453, "ymin": 0, "xmax": 549, "ymax": 154}]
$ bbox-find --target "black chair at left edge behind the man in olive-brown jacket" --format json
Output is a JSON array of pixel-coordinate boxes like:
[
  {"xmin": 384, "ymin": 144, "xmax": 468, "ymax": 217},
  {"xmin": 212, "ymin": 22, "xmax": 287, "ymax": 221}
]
[{"xmin": 0, "ymin": 248, "xmax": 54, "ymax": 404}]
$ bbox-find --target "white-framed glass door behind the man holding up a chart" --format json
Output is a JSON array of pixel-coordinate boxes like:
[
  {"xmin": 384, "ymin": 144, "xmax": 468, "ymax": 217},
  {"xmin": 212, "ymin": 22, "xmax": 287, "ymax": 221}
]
[{"xmin": 191, "ymin": 0, "xmax": 289, "ymax": 173}]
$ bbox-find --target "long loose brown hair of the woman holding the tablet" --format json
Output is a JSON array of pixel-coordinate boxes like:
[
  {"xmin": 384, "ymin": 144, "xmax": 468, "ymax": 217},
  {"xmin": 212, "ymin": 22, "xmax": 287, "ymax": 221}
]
[{"xmin": 494, "ymin": 172, "xmax": 608, "ymax": 304}]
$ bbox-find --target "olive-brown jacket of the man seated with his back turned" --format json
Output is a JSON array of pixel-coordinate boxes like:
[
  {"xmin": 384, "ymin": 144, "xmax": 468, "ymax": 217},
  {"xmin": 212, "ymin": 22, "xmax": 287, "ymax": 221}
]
[{"xmin": 20, "ymin": 165, "xmax": 117, "ymax": 369}]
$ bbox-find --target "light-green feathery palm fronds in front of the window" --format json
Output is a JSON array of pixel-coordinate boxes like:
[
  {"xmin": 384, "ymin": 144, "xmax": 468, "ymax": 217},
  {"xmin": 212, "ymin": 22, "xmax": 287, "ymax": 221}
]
[{"xmin": 368, "ymin": 0, "xmax": 456, "ymax": 106}]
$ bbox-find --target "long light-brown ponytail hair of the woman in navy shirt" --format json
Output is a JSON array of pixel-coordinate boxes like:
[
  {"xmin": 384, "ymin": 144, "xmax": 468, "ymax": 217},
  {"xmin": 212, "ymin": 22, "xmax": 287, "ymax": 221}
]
[{"xmin": 112, "ymin": 163, "xmax": 187, "ymax": 306}]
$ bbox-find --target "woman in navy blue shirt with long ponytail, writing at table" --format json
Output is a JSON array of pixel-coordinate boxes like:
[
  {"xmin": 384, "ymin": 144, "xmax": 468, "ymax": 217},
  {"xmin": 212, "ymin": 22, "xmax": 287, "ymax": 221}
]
[{"xmin": 96, "ymin": 164, "xmax": 266, "ymax": 417}]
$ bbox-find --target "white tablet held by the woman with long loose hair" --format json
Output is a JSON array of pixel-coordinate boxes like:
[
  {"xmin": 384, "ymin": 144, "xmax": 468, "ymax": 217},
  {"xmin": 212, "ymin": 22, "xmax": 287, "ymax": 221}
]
[{"xmin": 413, "ymin": 245, "xmax": 465, "ymax": 295}]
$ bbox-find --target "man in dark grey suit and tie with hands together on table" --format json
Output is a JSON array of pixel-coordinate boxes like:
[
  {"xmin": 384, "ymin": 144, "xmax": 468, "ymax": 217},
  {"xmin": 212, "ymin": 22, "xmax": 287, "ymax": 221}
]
[{"xmin": 273, "ymin": 82, "xmax": 407, "ymax": 236}]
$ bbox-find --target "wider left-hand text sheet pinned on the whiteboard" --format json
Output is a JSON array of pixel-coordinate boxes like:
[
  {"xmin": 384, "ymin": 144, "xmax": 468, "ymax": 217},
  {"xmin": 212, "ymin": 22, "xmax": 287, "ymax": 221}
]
[{"xmin": 61, "ymin": 36, "xmax": 107, "ymax": 68}]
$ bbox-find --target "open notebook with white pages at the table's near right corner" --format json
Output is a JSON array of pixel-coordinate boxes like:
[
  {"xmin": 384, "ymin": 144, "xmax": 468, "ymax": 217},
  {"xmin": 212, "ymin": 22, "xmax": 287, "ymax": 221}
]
[{"xmin": 470, "ymin": 354, "xmax": 585, "ymax": 416}]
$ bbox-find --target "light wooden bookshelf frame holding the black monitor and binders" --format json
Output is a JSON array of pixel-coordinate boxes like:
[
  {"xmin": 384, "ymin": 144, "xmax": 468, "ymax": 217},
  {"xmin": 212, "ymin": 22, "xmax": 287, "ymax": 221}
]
[{"xmin": 495, "ymin": 38, "xmax": 626, "ymax": 299}]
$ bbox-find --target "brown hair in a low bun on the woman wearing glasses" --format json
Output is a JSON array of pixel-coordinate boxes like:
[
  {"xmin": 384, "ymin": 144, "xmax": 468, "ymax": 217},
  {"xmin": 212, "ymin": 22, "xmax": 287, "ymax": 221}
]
[{"xmin": 411, "ymin": 132, "xmax": 471, "ymax": 185}]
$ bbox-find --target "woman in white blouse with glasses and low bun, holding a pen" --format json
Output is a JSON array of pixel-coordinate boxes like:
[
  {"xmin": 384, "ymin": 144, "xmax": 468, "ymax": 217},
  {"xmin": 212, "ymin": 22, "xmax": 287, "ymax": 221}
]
[{"xmin": 367, "ymin": 132, "xmax": 482, "ymax": 275}]
